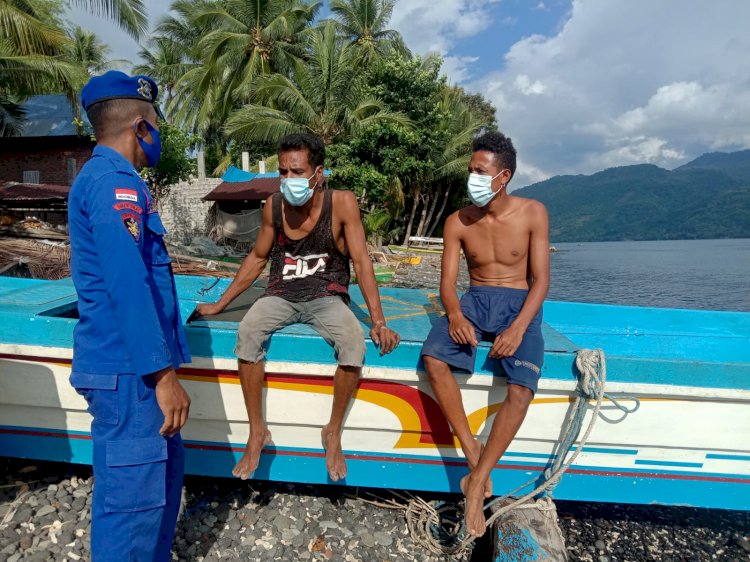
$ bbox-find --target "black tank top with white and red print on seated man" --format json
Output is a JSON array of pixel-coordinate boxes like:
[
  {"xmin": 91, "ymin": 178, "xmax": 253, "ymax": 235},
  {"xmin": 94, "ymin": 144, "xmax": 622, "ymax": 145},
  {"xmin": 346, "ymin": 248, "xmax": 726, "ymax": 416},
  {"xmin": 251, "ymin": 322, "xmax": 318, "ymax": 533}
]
[{"xmin": 265, "ymin": 189, "xmax": 350, "ymax": 304}]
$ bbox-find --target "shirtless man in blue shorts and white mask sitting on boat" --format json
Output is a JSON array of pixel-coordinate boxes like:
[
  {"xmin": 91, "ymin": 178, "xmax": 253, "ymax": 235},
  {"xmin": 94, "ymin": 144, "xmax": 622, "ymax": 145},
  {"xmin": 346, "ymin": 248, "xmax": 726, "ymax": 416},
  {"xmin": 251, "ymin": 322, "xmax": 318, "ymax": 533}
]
[{"xmin": 422, "ymin": 133, "xmax": 549, "ymax": 536}]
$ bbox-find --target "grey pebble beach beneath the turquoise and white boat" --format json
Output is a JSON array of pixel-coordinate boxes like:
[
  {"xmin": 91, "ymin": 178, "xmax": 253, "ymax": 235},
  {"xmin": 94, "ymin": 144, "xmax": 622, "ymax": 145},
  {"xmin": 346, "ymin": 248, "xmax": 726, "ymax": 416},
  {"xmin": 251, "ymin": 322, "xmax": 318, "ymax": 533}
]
[{"xmin": 0, "ymin": 457, "xmax": 750, "ymax": 562}]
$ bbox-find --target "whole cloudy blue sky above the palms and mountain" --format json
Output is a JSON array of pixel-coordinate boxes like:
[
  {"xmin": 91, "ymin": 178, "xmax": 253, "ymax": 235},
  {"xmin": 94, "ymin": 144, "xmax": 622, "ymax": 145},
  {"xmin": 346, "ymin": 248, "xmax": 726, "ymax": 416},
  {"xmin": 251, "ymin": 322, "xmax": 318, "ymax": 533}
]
[{"xmin": 64, "ymin": 0, "xmax": 750, "ymax": 188}]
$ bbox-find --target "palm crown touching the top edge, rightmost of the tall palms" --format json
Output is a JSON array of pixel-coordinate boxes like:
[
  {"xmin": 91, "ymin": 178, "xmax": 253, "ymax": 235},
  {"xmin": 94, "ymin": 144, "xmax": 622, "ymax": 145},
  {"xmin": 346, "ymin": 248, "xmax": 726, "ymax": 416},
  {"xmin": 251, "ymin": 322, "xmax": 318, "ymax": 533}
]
[{"xmin": 331, "ymin": 0, "xmax": 410, "ymax": 64}]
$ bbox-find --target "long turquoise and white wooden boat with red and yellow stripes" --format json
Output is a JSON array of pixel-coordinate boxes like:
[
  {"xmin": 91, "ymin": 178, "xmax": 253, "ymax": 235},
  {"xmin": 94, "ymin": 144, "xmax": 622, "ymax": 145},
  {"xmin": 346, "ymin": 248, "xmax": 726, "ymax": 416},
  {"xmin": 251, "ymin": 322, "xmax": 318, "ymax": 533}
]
[{"xmin": 0, "ymin": 276, "xmax": 750, "ymax": 510}]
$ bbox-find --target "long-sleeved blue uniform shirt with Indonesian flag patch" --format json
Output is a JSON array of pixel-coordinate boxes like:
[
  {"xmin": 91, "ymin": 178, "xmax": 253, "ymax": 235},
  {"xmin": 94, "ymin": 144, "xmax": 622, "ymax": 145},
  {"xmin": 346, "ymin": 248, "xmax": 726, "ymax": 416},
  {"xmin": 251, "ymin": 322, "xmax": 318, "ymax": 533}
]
[{"xmin": 68, "ymin": 146, "xmax": 190, "ymax": 389}]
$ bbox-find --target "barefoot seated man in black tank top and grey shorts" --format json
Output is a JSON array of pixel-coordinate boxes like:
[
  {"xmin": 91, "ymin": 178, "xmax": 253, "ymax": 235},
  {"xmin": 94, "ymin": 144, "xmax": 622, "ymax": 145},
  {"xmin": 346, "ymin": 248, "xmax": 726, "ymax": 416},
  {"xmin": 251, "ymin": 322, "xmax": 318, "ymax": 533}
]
[{"xmin": 196, "ymin": 134, "xmax": 400, "ymax": 481}]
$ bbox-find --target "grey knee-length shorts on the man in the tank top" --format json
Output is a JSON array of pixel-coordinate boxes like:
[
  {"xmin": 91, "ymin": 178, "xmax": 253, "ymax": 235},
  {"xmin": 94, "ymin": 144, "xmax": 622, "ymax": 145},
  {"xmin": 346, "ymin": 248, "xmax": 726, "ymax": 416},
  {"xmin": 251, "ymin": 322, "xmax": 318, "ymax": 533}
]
[{"xmin": 234, "ymin": 296, "xmax": 365, "ymax": 367}]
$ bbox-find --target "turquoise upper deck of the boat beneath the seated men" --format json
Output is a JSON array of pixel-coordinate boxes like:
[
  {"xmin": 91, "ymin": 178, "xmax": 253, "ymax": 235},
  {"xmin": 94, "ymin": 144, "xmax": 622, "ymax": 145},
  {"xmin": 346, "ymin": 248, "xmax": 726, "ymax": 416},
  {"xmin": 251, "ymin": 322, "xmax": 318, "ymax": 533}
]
[{"xmin": 0, "ymin": 276, "xmax": 750, "ymax": 390}]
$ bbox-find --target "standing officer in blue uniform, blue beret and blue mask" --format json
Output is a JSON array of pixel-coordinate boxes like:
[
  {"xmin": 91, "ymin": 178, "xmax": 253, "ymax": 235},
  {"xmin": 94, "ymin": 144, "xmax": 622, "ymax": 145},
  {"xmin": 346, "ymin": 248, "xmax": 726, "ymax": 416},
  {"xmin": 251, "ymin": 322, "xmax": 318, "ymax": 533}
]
[{"xmin": 68, "ymin": 71, "xmax": 190, "ymax": 562}]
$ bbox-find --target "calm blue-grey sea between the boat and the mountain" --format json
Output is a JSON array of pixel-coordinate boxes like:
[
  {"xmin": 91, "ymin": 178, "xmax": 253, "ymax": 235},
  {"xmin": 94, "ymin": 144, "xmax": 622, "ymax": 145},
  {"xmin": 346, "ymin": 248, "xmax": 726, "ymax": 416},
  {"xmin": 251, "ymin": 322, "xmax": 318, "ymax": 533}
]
[{"xmin": 547, "ymin": 239, "xmax": 750, "ymax": 311}]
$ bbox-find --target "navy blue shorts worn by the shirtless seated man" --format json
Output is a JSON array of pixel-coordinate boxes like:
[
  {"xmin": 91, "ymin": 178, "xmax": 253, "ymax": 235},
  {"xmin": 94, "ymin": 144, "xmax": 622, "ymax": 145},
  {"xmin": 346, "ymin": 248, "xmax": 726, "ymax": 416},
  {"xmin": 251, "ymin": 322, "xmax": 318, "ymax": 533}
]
[{"xmin": 421, "ymin": 286, "xmax": 544, "ymax": 393}]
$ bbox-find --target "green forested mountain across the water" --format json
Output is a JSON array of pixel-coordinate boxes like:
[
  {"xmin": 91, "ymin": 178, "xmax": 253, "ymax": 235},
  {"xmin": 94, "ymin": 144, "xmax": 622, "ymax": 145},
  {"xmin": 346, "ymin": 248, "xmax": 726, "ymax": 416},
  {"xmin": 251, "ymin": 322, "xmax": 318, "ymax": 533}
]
[{"xmin": 514, "ymin": 151, "xmax": 750, "ymax": 242}]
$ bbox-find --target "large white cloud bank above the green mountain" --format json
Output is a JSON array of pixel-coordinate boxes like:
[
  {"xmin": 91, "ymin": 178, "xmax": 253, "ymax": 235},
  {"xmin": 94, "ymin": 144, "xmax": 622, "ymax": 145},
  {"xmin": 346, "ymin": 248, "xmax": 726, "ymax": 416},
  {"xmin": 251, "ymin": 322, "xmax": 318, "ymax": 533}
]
[{"xmin": 470, "ymin": 0, "xmax": 750, "ymax": 183}]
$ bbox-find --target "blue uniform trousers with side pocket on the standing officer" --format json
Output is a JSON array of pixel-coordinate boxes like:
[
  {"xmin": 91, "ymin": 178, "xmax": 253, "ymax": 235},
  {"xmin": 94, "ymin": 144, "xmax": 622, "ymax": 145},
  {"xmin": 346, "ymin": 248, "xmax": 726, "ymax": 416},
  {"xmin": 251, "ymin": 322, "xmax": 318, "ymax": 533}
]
[{"xmin": 78, "ymin": 375, "xmax": 185, "ymax": 562}]
